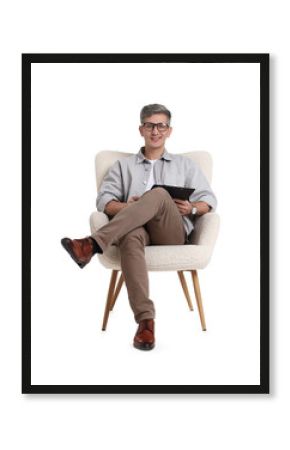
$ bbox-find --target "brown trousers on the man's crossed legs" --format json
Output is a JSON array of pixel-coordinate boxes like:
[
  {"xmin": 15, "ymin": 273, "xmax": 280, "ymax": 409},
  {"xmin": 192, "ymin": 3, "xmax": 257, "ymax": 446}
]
[{"xmin": 92, "ymin": 188, "xmax": 186, "ymax": 323}]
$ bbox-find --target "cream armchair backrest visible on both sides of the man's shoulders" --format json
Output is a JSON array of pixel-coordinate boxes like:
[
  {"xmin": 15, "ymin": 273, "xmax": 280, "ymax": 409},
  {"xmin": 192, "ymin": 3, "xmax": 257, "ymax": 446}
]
[{"xmin": 95, "ymin": 150, "xmax": 212, "ymax": 189}]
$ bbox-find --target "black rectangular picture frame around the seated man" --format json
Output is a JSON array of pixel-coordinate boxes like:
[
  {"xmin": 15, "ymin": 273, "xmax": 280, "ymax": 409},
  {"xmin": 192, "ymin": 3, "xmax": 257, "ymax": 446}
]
[{"xmin": 22, "ymin": 53, "xmax": 270, "ymax": 394}]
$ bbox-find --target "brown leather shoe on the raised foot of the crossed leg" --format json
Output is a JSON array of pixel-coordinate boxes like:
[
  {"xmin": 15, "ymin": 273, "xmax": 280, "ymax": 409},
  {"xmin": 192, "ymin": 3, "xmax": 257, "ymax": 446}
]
[{"xmin": 61, "ymin": 237, "xmax": 94, "ymax": 269}]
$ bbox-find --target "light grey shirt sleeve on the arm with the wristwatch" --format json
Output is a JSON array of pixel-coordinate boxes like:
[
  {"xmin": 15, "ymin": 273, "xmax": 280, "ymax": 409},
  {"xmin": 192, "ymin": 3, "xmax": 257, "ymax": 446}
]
[{"xmin": 189, "ymin": 164, "xmax": 217, "ymax": 211}]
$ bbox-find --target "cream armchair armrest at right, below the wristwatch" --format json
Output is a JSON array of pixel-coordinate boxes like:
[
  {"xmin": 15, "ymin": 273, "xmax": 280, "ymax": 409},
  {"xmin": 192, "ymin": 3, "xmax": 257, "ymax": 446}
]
[{"xmin": 193, "ymin": 212, "xmax": 220, "ymax": 248}]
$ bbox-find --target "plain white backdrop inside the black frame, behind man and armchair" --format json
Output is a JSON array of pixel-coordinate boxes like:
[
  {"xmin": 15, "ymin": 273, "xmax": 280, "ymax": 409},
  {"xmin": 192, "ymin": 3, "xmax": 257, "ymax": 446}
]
[{"xmin": 31, "ymin": 63, "xmax": 260, "ymax": 385}]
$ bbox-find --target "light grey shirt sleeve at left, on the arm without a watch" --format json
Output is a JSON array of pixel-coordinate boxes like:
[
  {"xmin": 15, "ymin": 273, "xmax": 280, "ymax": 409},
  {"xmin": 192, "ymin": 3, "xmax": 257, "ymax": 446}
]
[{"xmin": 96, "ymin": 161, "xmax": 124, "ymax": 212}]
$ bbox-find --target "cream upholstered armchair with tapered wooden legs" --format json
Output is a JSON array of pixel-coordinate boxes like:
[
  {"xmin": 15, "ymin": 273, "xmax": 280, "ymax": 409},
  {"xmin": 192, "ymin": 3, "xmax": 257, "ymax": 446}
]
[{"xmin": 90, "ymin": 151, "xmax": 219, "ymax": 331}]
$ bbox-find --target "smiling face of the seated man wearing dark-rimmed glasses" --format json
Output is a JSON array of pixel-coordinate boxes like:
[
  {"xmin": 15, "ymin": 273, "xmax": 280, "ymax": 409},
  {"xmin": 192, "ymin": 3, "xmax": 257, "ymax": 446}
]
[{"xmin": 139, "ymin": 114, "xmax": 172, "ymax": 149}]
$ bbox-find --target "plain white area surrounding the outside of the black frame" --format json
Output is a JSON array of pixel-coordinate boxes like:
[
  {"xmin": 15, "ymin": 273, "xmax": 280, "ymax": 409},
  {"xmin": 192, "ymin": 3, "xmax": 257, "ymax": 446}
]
[{"xmin": 0, "ymin": 1, "xmax": 290, "ymax": 449}]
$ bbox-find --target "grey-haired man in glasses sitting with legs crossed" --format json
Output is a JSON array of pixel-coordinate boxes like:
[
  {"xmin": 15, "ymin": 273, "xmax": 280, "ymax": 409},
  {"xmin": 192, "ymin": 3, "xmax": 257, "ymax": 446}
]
[{"xmin": 61, "ymin": 104, "xmax": 216, "ymax": 350}]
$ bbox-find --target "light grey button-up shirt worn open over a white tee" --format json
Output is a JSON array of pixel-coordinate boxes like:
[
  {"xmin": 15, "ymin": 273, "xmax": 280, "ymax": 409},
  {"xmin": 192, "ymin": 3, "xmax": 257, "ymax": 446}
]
[{"xmin": 97, "ymin": 147, "xmax": 217, "ymax": 234}]
